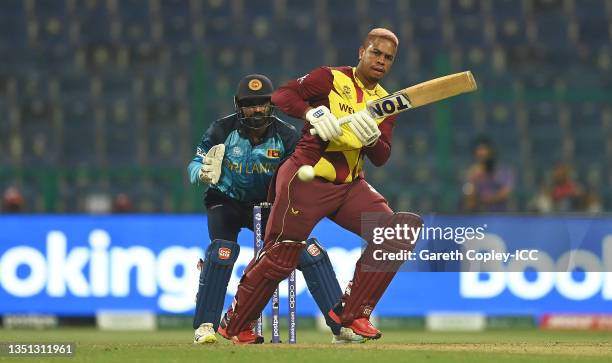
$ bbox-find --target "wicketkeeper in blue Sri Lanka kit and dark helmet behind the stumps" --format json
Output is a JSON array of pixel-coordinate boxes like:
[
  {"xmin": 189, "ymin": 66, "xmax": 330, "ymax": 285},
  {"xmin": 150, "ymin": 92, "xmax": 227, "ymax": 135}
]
[{"xmin": 188, "ymin": 74, "xmax": 363, "ymax": 344}]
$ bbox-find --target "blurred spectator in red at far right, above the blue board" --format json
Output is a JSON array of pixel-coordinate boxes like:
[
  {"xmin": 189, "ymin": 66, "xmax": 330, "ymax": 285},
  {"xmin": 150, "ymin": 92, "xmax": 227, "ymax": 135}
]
[{"xmin": 533, "ymin": 163, "xmax": 602, "ymax": 213}]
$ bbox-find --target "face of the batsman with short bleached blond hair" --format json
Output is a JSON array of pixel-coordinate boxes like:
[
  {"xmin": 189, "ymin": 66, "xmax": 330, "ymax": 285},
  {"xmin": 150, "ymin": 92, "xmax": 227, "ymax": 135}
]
[{"xmin": 359, "ymin": 38, "xmax": 397, "ymax": 81}]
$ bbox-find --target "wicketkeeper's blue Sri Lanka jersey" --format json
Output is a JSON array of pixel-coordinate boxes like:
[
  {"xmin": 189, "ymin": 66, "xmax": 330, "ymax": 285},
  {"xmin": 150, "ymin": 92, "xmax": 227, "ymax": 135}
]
[{"xmin": 187, "ymin": 114, "xmax": 299, "ymax": 202}]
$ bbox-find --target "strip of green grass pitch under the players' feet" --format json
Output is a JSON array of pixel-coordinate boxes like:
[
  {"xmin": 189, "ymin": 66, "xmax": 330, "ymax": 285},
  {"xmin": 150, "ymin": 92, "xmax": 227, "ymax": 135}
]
[{"xmin": 0, "ymin": 329, "xmax": 612, "ymax": 363}]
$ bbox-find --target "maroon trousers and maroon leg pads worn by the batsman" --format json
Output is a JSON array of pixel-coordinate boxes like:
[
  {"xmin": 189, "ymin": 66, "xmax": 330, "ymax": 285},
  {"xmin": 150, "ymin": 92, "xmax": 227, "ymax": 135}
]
[{"xmin": 227, "ymin": 159, "xmax": 406, "ymax": 335}]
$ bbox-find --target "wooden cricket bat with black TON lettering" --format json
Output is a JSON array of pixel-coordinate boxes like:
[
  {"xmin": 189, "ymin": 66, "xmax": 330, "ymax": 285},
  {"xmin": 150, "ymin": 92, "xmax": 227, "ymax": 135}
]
[{"xmin": 310, "ymin": 71, "xmax": 478, "ymax": 135}]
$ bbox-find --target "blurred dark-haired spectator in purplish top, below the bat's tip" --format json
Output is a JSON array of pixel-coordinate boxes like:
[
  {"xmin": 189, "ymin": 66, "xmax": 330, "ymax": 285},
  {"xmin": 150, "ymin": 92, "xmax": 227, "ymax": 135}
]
[{"xmin": 463, "ymin": 137, "xmax": 514, "ymax": 212}]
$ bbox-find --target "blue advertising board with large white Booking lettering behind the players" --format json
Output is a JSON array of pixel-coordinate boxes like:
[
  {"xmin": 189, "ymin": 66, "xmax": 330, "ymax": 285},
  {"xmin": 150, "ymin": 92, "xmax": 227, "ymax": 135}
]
[{"xmin": 0, "ymin": 215, "xmax": 612, "ymax": 316}]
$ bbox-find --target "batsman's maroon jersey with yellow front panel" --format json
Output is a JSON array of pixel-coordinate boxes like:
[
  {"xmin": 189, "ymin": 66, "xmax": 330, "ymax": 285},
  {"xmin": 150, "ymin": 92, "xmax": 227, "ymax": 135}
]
[{"xmin": 272, "ymin": 67, "xmax": 395, "ymax": 183}]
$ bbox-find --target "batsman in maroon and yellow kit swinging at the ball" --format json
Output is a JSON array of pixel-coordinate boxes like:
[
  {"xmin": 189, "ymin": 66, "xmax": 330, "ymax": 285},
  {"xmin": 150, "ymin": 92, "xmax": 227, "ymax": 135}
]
[{"xmin": 219, "ymin": 28, "xmax": 422, "ymax": 343}]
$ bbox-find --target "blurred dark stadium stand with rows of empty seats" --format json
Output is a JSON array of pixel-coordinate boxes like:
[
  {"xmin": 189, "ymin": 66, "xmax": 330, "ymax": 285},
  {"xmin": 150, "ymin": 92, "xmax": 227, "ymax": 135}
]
[{"xmin": 0, "ymin": 0, "xmax": 612, "ymax": 213}]
